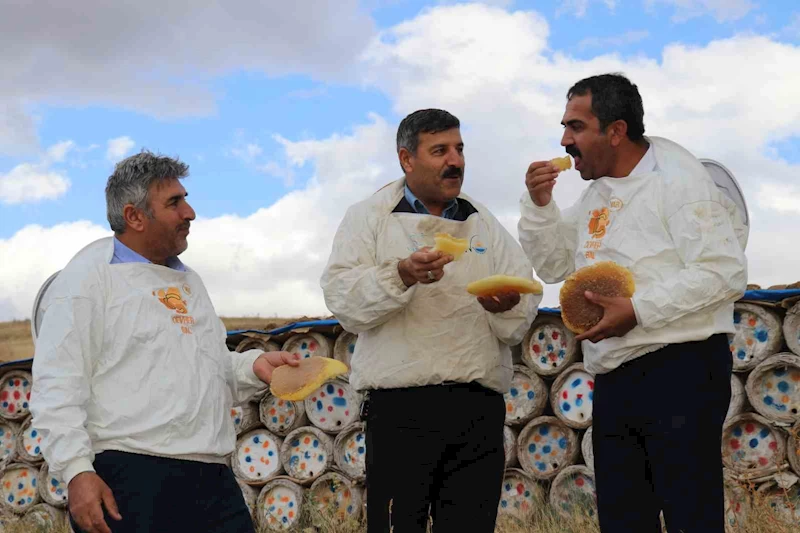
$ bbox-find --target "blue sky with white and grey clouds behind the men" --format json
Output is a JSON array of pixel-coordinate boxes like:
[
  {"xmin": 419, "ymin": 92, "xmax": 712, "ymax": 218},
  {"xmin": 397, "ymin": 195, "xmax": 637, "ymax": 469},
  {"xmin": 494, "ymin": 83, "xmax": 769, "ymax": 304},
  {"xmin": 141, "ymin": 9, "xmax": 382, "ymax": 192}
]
[{"xmin": 0, "ymin": 0, "xmax": 800, "ymax": 321}]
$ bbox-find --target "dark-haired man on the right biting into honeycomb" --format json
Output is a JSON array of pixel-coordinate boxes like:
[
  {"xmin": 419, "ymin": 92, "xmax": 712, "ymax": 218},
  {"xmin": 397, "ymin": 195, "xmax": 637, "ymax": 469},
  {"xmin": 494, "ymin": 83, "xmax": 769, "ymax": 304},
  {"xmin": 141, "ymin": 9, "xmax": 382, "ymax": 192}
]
[{"xmin": 519, "ymin": 74, "xmax": 747, "ymax": 533}]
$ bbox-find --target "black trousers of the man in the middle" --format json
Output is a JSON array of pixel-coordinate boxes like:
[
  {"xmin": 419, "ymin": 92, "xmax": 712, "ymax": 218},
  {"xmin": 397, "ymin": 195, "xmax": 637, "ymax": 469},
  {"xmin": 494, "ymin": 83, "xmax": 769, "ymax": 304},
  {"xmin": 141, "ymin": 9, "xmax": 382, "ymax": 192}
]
[{"xmin": 365, "ymin": 384, "xmax": 505, "ymax": 533}]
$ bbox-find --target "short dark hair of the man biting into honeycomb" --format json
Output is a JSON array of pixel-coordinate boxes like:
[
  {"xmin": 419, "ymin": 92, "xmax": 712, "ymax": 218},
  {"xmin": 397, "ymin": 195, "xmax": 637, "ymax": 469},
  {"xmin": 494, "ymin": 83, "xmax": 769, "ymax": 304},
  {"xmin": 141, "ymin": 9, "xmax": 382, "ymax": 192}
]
[{"xmin": 567, "ymin": 74, "xmax": 644, "ymax": 141}]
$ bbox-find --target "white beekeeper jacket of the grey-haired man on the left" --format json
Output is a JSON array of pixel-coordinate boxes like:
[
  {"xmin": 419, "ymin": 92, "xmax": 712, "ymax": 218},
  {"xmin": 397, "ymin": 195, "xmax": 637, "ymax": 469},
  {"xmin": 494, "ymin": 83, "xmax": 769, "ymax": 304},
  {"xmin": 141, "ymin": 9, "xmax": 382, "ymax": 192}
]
[{"xmin": 31, "ymin": 237, "xmax": 266, "ymax": 484}]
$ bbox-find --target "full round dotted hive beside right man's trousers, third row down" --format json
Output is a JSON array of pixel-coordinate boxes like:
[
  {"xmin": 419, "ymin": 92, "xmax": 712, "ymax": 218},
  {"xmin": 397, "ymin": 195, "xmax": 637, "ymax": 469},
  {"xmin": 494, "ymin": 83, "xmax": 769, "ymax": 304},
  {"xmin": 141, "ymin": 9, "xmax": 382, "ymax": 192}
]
[{"xmin": 722, "ymin": 413, "xmax": 786, "ymax": 479}]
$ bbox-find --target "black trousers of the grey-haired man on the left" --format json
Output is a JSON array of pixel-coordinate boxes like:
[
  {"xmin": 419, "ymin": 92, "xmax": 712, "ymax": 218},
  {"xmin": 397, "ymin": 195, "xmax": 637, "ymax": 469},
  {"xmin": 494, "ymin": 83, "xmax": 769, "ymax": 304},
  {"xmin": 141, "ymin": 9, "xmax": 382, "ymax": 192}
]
[{"xmin": 70, "ymin": 451, "xmax": 254, "ymax": 533}]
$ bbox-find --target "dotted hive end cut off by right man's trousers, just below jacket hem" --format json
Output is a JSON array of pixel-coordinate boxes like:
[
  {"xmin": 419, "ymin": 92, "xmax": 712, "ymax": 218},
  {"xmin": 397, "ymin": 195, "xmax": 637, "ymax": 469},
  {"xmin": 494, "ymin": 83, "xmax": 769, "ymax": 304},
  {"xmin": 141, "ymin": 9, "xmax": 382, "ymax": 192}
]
[{"xmin": 550, "ymin": 363, "xmax": 594, "ymax": 429}]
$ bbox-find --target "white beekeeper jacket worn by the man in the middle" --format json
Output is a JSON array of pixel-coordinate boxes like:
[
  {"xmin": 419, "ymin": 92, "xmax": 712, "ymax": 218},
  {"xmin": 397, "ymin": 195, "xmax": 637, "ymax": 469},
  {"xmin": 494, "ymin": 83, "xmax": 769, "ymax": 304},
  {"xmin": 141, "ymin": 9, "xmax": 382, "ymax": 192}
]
[{"xmin": 321, "ymin": 179, "xmax": 542, "ymax": 393}]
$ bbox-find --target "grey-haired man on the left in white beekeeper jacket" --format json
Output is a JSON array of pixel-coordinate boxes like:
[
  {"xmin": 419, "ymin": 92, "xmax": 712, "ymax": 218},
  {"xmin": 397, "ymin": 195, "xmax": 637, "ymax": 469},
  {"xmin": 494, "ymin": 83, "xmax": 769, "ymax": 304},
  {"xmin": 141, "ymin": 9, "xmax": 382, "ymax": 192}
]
[{"xmin": 31, "ymin": 152, "xmax": 297, "ymax": 533}]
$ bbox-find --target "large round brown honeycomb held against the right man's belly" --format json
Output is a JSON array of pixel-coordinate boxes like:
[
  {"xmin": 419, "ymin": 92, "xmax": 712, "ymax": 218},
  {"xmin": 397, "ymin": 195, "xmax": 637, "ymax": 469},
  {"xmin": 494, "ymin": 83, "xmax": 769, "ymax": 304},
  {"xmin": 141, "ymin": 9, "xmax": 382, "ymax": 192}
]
[{"xmin": 559, "ymin": 261, "xmax": 636, "ymax": 334}]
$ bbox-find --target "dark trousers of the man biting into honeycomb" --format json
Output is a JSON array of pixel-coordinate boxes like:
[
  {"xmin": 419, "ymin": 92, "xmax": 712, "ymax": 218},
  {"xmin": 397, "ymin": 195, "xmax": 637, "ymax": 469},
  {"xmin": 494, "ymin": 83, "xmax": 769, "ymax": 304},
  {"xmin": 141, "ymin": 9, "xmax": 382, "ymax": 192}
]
[{"xmin": 592, "ymin": 335, "xmax": 733, "ymax": 533}]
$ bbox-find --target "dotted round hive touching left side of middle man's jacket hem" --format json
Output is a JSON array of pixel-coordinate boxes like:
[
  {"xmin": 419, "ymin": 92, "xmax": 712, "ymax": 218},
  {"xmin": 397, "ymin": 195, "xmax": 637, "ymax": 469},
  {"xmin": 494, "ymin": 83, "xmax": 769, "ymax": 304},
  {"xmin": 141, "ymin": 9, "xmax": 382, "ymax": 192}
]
[{"xmin": 304, "ymin": 379, "xmax": 361, "ymax": 433}]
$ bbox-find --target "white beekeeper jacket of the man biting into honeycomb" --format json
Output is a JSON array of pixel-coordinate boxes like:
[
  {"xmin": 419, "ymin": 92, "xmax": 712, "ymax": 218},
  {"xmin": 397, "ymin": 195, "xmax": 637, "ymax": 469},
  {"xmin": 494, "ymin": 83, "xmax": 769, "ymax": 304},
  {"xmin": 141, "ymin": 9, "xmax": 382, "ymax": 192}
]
[{"xmin": 519, "ymin": 137, "xmax": 747, "ymax": 374}]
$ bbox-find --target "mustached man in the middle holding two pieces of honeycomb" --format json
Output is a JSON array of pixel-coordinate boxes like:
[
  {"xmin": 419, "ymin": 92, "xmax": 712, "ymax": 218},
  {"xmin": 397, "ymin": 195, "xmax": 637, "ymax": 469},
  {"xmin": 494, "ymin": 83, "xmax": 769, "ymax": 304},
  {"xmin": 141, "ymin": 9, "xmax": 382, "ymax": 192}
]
[{"xmin": 321, "ymin": 109, "xmax": 541, "ymax": 533}]
